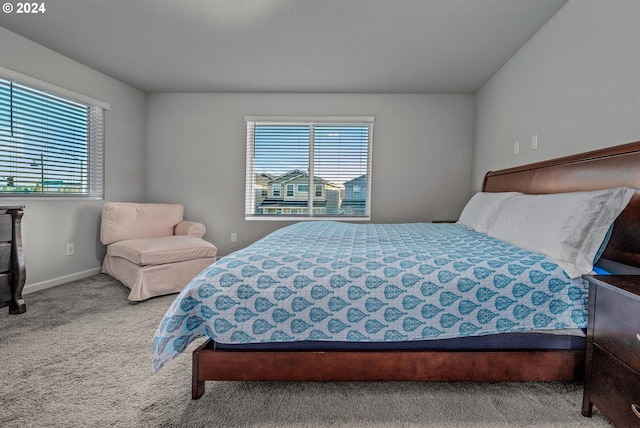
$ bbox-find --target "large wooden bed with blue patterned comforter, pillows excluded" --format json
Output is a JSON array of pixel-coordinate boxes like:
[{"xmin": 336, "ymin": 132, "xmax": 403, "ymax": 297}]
[{"xmin": 153, "ymin": 142, "xmax": 640, "ymax": 399}]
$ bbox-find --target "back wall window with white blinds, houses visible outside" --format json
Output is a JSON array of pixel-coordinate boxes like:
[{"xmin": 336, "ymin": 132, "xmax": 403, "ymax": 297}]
[{"xmin": 245, "ymin": 116, "xmax": 374, "ymax": 220}]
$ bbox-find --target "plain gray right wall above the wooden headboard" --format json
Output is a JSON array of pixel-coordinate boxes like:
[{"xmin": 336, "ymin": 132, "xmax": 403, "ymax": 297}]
[{"xmin": 472, "ymin": 0, "xmax": 640, "ymax": 191}]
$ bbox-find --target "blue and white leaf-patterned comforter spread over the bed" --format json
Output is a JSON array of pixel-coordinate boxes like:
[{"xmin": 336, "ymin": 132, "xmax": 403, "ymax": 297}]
[{"xmin": 153, "ymin": 221, "xmax": 587, "ymax": 371}]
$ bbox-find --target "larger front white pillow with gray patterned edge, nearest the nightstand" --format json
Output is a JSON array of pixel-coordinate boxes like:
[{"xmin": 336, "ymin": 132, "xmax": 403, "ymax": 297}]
[{"xmin": 487, "ymin": 187, "xmax": 636, "ymax": 278}]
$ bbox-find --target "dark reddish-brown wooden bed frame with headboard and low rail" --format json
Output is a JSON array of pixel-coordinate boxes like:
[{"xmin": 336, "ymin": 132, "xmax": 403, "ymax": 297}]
[{"xmin": 192, "ymin": 141, "xmax": 640, "ymax": 399}]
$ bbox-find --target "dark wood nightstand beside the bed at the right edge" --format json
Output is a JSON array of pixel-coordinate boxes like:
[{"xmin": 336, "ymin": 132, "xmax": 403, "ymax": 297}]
[{"xmin": 582, "ymin": 275, "xmax": 640, "ymax": 427}]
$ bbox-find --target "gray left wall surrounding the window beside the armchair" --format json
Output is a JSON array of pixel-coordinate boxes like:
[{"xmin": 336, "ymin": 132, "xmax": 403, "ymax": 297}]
[{"xmin": 0, "ymin": 27, "xmax": 145, "ymax": 294}]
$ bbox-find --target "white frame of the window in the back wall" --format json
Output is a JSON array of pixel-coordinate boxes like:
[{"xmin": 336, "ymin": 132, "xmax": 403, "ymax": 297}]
[{"xmin": 245, "ymin": 116, "xmax": 375, "ymax": 221}]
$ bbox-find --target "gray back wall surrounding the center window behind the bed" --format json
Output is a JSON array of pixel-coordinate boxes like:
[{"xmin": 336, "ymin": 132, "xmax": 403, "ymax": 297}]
[{"xmin": 145, "ymin": 93, "xmax": 474, "ymax": 255}]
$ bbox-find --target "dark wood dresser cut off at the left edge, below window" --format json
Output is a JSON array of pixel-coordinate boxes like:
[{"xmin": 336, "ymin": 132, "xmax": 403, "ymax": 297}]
[{"xmin": 0, "ymin": 205, "xmax": 27, "ymax": 314}]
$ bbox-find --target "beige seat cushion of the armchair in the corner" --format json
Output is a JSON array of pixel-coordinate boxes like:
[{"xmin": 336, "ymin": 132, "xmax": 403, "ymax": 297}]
[{"xmin": 107, "ymin": 235, "xmax": 218, "ymax": 266}]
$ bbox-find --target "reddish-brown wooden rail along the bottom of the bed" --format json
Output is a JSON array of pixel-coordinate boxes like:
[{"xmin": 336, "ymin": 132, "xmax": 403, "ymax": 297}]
[{"xmin": 191, "ymin": 342, "xmax": 584, "ymax": 400}]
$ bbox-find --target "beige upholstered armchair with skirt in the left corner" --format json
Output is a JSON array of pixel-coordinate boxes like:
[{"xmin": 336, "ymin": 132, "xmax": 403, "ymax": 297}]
[{"xmin": 100, "ymin": 202, "xmax": 218, "ymax": 301}]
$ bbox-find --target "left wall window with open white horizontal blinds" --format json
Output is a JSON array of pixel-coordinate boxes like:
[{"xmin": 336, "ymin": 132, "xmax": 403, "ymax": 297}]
[{"xmin": 0, "ymin": 76, "xmax": 104, "ymax": 199}]
